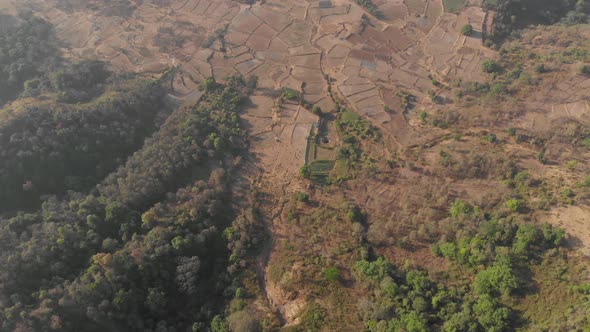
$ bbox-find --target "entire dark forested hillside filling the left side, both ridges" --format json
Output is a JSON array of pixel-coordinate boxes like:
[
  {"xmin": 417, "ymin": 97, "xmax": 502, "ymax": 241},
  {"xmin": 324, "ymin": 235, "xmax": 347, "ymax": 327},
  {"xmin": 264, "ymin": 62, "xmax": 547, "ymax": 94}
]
[{"xmin": 0, "ymin": 17, "xmax": 260, "ymax": 331}]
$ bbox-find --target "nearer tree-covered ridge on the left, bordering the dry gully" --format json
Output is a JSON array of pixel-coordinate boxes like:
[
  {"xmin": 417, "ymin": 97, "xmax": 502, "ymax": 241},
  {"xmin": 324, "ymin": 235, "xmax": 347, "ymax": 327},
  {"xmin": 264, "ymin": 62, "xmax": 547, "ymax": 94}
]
[{"xmin": 0, "ymin": 78, "xmax": 248, "ymax": 331}]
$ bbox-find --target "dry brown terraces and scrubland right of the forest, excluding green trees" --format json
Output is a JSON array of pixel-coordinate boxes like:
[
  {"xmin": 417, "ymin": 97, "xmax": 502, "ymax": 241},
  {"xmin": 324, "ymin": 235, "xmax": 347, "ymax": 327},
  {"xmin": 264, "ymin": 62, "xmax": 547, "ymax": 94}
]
[{"xmin": 0, "ymin": 0, "xmax": 590, "ymax": 331}]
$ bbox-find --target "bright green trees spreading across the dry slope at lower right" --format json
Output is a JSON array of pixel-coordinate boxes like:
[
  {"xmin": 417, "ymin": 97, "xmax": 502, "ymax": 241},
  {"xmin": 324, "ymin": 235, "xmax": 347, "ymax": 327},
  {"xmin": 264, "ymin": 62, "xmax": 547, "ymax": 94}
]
[{"xmin": 356, "ymin": 217, "xmax": 565, "ymax": 331}]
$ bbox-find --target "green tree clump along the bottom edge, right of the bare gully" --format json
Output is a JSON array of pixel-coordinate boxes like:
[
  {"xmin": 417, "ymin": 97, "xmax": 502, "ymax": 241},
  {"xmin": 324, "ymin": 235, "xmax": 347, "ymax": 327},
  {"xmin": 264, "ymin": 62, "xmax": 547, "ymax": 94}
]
[{"xmin": 356, "ymin": 258, "xmax": 513, "ymax": 332}]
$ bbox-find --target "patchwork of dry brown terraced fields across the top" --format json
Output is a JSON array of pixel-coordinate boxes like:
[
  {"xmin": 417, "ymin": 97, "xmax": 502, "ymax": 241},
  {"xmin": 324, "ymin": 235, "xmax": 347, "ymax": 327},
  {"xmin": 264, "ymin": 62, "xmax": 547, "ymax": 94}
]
[{"xmin": 4, "ymin": 0, "xmax": 590, "ymax": 151}]
